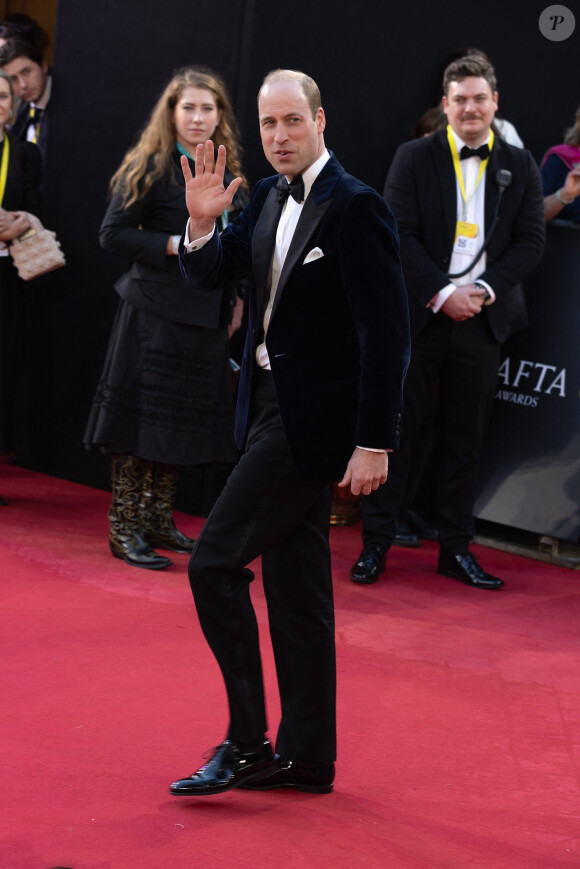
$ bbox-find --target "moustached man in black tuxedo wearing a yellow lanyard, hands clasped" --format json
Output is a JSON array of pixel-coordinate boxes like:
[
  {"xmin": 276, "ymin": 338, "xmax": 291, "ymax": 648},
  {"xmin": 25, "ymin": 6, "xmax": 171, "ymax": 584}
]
[{"xmin": 351, "ymin": 58, "xmax": 544, "ymax": 589}]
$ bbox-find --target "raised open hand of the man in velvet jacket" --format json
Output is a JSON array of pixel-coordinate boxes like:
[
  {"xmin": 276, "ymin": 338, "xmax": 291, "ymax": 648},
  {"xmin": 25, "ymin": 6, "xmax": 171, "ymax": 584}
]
[{"xmin": 181, "ymin": 139, "xmax": 242, "ymax": 239}]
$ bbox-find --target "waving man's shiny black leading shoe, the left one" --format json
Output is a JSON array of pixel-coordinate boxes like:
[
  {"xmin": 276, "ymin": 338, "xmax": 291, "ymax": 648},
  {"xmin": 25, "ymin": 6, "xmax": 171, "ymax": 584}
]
[{"xmin": 169, "ymin": 739, "xmax": 274, "ymax": 797}]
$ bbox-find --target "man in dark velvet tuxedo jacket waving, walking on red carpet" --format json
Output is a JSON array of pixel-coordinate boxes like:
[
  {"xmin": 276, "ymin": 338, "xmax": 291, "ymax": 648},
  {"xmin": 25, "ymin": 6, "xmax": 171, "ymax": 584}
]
[{"xmin": 170, "ymin": 70, "xmax": 409, "ymax": 796}]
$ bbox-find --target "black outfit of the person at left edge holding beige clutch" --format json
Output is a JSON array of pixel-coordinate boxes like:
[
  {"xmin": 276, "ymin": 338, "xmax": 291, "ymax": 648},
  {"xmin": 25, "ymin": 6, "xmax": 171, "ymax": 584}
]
[{"xmin": 0, "ymin": 131, "xmax": 42, "ymax": 455}]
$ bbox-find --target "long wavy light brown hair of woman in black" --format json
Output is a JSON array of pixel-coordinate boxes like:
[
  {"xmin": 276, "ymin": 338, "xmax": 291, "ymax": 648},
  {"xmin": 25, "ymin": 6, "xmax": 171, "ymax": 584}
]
[{"xmin": 110, "ymin": 66, "xmax": 249, "ymax": 206}]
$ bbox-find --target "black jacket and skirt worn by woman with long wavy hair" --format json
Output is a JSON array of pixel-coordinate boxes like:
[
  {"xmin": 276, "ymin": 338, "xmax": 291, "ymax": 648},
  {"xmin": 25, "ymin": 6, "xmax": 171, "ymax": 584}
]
[{"xmin": 84, "ymin": 152, "xmax": 245, "ymax": 465}]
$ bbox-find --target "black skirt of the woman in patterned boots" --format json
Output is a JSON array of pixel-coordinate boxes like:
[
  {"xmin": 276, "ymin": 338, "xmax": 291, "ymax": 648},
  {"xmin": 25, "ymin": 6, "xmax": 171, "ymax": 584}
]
[{"xmin": 84, "ymin": 300, "xmax": 237, "ymax": 465}]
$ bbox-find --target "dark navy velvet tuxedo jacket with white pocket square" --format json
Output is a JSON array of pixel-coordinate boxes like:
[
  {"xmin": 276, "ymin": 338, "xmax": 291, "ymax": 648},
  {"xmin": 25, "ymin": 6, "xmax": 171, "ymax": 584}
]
[{"xmin": 181, "ymin": 156, "xmax": 409, "ymax": 482}]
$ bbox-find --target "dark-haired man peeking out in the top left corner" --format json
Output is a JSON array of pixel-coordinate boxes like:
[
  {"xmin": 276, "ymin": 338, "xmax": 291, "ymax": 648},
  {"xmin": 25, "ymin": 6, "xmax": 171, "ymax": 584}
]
[{"xmin": 0, "ymin": 39, "xmax": 52, "ymax": 157}]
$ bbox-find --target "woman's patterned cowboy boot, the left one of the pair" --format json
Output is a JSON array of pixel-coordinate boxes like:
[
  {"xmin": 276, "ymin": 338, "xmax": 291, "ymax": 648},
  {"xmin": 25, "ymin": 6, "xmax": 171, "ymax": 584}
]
[{"xmin": 109, "ymin": 455, "xmax": 172, "ymax": 570}]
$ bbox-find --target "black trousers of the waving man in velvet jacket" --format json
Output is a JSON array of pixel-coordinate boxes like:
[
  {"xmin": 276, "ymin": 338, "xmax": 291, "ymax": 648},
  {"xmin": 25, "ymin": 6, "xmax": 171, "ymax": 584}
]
[{"xmin": 189, "ymin": 372, "xmax": 336, "ymax": 763}]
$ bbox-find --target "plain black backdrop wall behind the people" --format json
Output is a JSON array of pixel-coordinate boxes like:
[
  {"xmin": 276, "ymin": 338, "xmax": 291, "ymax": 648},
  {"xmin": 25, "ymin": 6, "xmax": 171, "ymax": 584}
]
[{"xmin": 20, "ymin": 0, "xmax": 580, "ymax": 513}]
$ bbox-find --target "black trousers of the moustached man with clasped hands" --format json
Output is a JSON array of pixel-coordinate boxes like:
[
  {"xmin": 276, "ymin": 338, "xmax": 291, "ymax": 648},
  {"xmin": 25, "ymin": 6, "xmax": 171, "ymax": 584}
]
[{"xmin": 362, "ymin": 311, "xmax": 500, "ymax": 553}]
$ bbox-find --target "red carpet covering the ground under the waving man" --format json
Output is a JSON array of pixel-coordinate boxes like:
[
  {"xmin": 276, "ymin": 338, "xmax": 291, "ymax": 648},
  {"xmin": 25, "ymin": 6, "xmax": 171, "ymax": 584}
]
[{"xmin": 0, "ymin": 465, "xmax": 580, "ymax": 869}]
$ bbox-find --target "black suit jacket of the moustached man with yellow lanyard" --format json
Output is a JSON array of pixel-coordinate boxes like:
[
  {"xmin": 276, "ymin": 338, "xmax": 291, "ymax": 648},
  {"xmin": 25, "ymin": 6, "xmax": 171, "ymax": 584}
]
[{"xmin": 384, "ymin": 130, "xmax": 545, "ymax": 342}]
